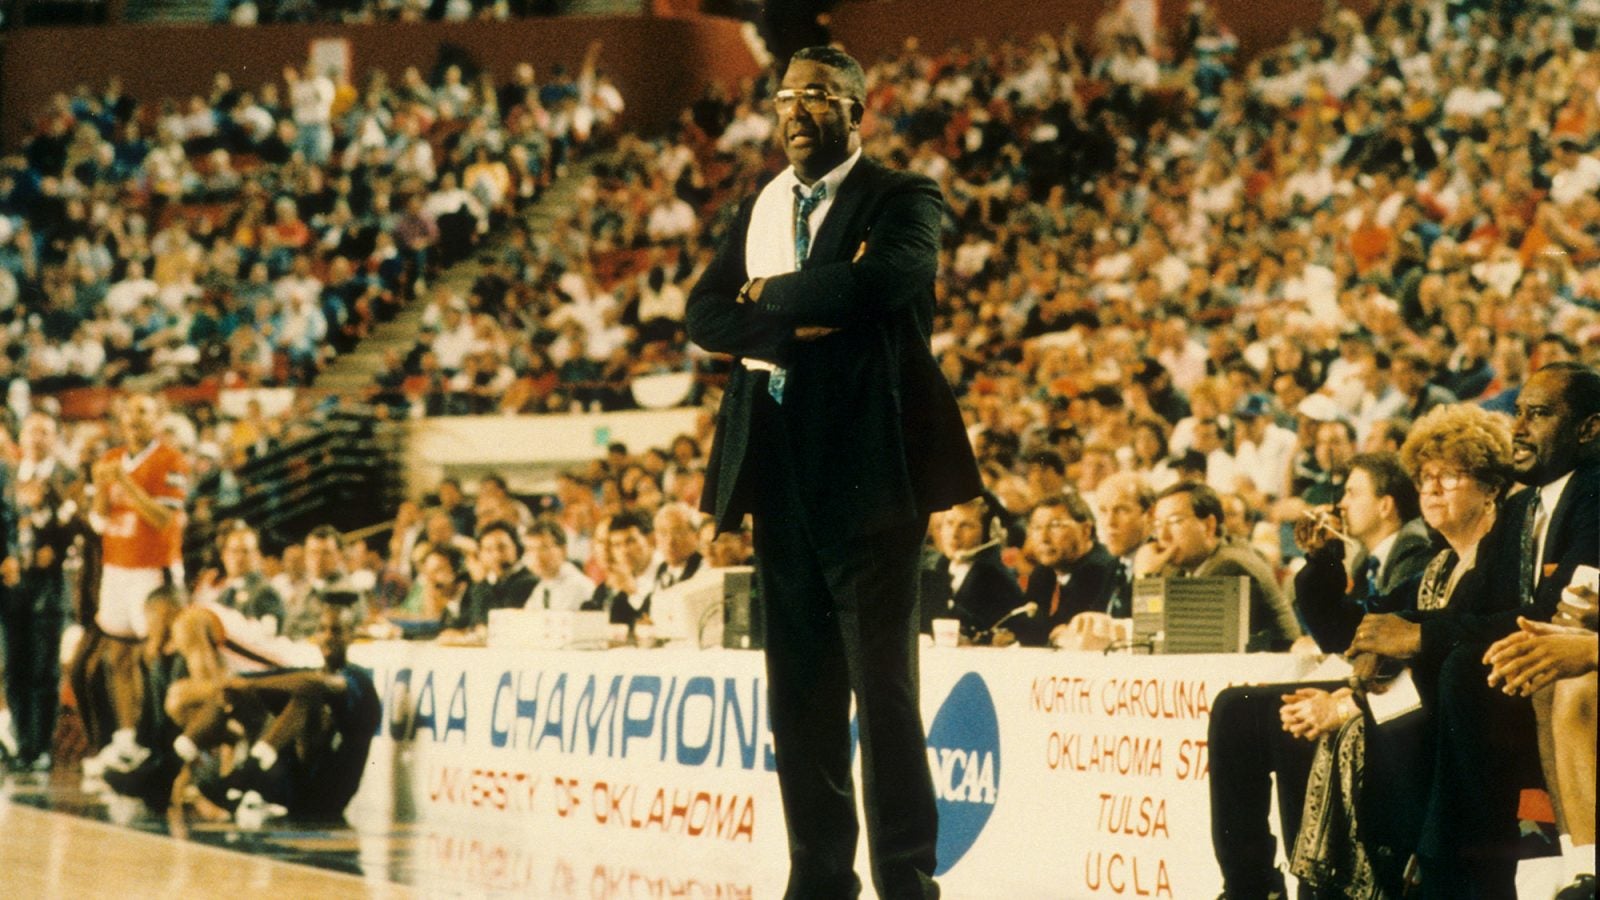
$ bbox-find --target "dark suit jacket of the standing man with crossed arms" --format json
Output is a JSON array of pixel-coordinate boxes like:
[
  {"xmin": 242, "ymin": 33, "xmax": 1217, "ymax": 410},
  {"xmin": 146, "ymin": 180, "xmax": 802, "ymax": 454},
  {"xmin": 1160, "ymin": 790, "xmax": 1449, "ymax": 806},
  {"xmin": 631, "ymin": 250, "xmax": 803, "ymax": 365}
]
[{"xmin": 686, "ymin": 157, "xmax": 982, "ymax": 548}]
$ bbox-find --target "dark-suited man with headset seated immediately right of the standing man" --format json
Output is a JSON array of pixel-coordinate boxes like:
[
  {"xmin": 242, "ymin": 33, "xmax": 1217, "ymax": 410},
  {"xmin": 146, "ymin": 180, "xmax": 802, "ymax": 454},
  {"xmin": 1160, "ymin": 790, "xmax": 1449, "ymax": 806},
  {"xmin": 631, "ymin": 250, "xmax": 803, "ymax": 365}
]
[{"xmin": 922, "ymin": 498, "xmax": 1022, "ymax": 644}]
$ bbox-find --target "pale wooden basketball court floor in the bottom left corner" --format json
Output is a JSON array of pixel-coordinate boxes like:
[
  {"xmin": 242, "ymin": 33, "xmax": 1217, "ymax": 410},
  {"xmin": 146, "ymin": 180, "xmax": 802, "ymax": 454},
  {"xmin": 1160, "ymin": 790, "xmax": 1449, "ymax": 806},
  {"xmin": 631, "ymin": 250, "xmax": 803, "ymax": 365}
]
[{"xmin": 0, "ymin": 772, "xmax": 422, "ymax": 900}]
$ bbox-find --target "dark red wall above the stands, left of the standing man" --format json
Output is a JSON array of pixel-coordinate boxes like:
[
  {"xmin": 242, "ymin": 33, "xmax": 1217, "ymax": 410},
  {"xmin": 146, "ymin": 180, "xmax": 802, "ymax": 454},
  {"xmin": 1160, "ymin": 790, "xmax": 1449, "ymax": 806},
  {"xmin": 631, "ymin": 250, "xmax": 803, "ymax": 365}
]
[{"xmin": 0, "ymin": 16, "xmax": 757, "ymax": 147}]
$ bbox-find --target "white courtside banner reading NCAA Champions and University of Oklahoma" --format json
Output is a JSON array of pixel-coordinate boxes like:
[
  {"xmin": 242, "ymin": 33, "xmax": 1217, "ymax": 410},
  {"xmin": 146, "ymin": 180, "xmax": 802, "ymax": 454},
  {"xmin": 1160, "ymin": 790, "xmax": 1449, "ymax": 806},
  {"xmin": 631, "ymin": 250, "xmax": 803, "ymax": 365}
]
[{"xmin": 349, "ymin": 642, "xmax": 1315, "ymax": 898}]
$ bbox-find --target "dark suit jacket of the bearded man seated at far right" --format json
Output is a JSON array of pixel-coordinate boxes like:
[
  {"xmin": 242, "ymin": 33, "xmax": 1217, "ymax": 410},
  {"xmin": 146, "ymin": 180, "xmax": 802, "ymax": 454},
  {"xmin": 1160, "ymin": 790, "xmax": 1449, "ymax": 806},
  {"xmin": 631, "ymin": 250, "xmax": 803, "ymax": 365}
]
[{"xmin": 1411, "ymin": 463, "xmax": 1600, "ymax": 669}]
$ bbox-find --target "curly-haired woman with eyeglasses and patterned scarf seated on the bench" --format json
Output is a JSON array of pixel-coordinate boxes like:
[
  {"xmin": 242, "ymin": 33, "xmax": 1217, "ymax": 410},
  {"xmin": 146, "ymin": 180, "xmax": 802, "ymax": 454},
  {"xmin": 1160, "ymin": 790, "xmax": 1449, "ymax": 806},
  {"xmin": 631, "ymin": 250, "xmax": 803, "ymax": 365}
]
[{"xmin": 1283, "ymin": 404, "xmax": 1512, "ymax": 898}]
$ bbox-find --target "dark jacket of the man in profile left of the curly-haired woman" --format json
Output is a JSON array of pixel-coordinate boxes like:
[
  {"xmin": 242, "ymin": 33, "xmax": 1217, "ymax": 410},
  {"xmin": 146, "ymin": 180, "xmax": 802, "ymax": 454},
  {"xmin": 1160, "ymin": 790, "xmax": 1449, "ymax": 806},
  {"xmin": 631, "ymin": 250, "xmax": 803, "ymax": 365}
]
[{"xmin": 1294, "ymin": 519, "xmax": 1440, "ymax": 653}]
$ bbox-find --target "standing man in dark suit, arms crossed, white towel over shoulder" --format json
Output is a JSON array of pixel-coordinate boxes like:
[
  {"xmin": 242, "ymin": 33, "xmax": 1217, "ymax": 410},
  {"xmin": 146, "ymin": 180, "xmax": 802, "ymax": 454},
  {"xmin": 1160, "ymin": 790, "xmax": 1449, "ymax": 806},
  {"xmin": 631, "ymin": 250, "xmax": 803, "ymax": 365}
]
[{"xmin": 686, "ymin": 46, "xmax": 982, "ymax": 897}]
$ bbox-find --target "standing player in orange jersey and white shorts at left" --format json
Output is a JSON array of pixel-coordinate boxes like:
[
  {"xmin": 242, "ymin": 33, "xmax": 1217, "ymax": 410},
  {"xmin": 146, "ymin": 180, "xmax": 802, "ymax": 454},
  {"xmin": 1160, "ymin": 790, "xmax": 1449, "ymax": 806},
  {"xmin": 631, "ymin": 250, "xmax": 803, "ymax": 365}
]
[{"xmin": 85, "ymin": 394, "xmax": 189, "ymax": 775}]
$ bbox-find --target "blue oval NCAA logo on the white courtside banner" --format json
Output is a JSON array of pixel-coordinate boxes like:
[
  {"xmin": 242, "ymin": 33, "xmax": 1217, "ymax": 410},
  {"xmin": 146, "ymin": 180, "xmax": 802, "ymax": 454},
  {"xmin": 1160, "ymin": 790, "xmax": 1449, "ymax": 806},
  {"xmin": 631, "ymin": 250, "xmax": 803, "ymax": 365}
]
[{"xmin": 928, "ymin": 673, "xmax": 1000, "ymax": 874}]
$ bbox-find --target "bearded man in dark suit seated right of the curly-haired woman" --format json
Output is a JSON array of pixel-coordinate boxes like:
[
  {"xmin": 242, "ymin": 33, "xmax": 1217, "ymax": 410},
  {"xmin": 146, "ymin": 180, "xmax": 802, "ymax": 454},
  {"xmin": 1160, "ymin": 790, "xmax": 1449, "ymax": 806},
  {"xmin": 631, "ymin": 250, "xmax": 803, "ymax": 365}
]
[{"xmin": 1350, "ymin": 362, "xmax": 1600, "ymax": 898}]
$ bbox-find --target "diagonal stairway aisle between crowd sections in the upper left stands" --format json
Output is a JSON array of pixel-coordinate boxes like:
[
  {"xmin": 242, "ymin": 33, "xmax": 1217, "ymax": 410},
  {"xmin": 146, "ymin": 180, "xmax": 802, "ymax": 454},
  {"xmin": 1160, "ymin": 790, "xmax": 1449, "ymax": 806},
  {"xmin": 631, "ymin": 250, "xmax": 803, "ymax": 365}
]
[{"xmin": 312, "ymin": 159, "xmax": 594, "ymax": 396}]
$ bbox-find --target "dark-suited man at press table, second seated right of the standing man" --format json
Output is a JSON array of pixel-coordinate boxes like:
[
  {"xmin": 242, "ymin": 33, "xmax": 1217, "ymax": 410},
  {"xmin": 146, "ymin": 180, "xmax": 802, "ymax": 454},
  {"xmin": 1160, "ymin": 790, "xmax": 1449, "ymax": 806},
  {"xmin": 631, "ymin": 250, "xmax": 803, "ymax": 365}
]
[{"xmin": 1010, "ymin": 490, "xmax": 1117, "ymax": 647}]
